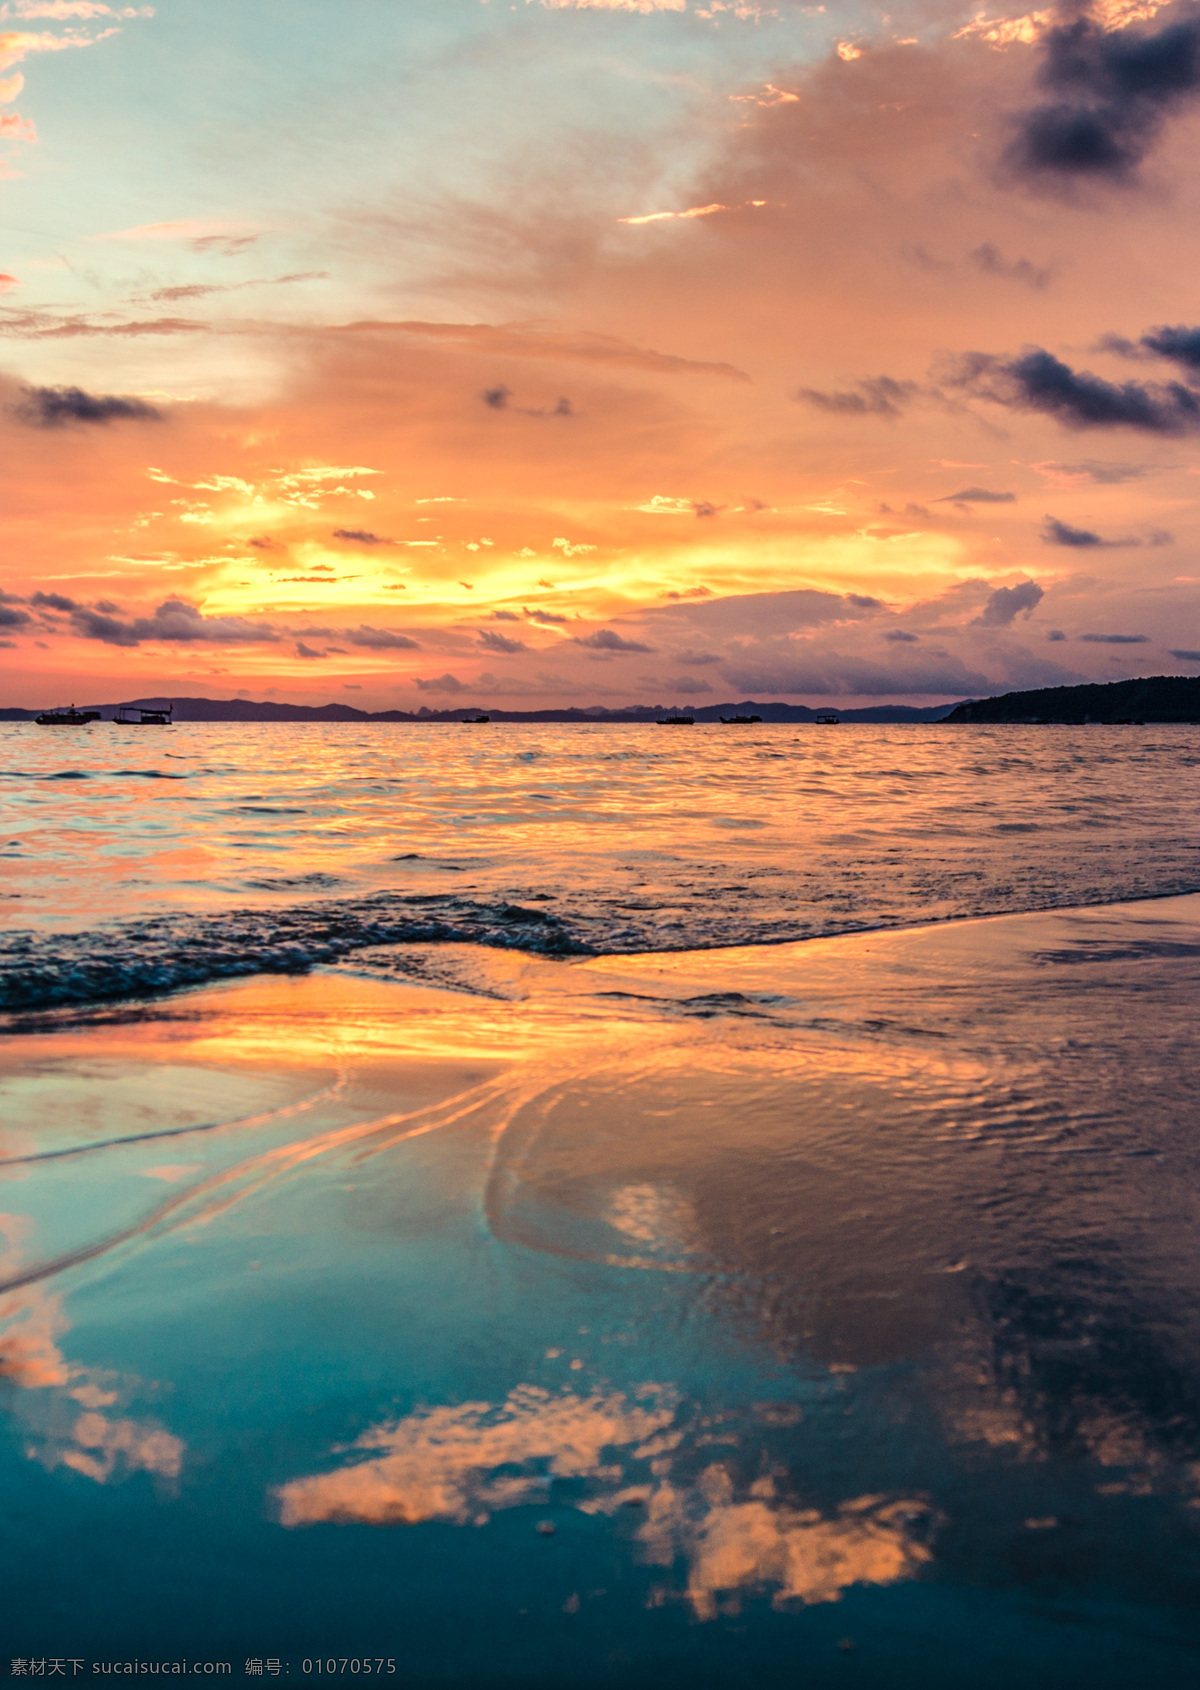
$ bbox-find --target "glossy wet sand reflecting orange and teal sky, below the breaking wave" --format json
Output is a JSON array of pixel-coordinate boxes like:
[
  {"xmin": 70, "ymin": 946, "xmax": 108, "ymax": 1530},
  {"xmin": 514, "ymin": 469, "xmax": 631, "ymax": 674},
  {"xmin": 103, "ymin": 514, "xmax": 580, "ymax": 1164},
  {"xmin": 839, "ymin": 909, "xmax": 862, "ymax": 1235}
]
[{"xmin": 0, "ymin": 897, "xmax": 1200, "ymax": 1687}]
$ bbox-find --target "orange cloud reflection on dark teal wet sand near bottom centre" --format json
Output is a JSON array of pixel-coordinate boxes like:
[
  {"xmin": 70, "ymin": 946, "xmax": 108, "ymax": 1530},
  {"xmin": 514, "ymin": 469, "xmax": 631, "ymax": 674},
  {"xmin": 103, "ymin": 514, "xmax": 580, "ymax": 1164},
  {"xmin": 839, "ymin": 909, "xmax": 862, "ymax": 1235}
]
[{"xmin": 277, "ymin": 1384, "xmax": 940, "ymax": 1619}]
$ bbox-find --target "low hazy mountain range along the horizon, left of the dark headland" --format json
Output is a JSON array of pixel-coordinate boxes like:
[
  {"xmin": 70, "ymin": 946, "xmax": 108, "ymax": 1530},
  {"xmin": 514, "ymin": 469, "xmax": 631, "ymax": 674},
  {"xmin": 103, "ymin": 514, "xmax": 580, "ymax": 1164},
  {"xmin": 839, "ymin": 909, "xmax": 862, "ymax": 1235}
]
[{"xmin": 0, "ymin": 696, "xmax": 965, "ymax": 722}]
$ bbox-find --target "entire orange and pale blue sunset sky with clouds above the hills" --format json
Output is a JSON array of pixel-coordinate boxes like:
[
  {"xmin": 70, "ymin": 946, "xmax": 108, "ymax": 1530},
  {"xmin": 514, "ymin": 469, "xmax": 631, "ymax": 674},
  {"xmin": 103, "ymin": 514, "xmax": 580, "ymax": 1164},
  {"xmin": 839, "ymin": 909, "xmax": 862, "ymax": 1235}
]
[{"xmin": 0, "ymin": 0, "xmax": 1200, "ymax": 710}]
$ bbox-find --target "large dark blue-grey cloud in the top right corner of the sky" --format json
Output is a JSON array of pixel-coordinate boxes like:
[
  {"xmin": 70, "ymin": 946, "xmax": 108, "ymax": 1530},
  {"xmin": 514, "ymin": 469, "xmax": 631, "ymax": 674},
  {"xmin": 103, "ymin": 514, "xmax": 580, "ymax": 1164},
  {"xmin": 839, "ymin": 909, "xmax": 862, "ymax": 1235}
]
[{"xmin": 1006, "ymin": 17, "xmax": 1200, "ymax": 183}]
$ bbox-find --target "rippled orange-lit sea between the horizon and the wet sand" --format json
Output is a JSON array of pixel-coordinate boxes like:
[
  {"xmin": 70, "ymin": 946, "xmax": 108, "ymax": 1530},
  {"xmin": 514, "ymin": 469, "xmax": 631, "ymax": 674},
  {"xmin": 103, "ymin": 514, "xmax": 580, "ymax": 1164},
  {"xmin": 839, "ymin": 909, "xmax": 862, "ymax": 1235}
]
[{"xmin": 0, "ymin": 723, "xmax": 1200, "ymax": 1009}]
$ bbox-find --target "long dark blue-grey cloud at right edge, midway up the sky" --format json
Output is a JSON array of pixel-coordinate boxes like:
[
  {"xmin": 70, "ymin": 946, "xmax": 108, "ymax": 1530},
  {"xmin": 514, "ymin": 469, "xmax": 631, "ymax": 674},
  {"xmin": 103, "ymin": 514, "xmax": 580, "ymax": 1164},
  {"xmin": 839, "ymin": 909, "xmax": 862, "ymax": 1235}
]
[{"xmin": 945, "ymin": 346, "xmax": 1200, "ymax": 434}]
